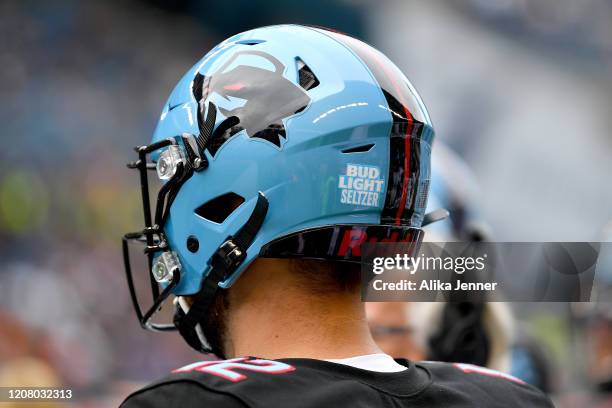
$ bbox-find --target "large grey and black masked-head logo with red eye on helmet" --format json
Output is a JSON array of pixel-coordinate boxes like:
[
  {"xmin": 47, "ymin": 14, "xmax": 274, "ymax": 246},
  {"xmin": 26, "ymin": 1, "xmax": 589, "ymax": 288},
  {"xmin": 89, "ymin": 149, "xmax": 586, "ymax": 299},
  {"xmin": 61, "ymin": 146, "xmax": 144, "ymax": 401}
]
[{"xmin": 192, "ymin": 51, "xmax": 310, "ymax": 156}]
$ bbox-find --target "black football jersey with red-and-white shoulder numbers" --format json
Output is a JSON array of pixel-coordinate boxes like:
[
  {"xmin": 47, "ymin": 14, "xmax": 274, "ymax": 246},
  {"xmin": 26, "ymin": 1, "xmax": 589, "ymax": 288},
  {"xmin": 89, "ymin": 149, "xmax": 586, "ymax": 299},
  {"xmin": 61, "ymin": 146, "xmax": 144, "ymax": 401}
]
[{"xmin": 121, "ymin": 357, "xmax": 553, "ymax": 408}]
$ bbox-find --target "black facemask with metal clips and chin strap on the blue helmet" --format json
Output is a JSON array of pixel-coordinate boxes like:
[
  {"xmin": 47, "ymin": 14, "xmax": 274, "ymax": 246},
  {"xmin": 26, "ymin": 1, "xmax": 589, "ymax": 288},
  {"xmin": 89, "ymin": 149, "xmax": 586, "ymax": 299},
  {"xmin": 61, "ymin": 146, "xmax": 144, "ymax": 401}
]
[{"xmin": 122, "ymin": 112, "xmax": 268, "ymax": 353}]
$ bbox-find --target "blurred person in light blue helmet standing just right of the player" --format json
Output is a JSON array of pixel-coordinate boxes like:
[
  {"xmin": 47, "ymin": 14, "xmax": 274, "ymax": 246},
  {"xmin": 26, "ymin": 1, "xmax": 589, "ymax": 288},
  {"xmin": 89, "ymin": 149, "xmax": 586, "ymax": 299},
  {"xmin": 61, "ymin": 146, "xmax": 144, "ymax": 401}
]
[{"xmin": 413, "ymin": 143, "xmax": 520, "ymax": 372}]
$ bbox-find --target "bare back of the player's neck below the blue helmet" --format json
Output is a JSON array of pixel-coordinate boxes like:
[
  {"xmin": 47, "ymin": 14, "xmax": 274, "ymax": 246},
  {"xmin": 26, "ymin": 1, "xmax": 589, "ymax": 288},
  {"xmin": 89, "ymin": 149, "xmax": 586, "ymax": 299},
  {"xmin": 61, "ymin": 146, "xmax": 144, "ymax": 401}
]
[{"xmin": 226, "ymin": 260, "xmax": 381, "ymax": 359}]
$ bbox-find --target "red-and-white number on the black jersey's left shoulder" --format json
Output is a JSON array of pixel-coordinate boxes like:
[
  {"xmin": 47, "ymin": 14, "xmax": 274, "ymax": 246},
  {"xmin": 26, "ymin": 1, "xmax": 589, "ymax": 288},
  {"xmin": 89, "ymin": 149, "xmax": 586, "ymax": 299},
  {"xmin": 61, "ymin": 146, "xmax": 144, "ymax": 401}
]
[{"xmin": 173, "ymin": 357, "xmax": 295, "ymax": 382}]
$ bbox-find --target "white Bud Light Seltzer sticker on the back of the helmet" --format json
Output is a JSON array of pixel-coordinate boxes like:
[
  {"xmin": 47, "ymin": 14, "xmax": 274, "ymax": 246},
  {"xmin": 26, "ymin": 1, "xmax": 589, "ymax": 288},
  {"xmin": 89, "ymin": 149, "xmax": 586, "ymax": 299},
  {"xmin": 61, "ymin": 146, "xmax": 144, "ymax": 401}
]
[{"xmin": 338, "ymin": 164, "xmax": 385, "ymax": 207}]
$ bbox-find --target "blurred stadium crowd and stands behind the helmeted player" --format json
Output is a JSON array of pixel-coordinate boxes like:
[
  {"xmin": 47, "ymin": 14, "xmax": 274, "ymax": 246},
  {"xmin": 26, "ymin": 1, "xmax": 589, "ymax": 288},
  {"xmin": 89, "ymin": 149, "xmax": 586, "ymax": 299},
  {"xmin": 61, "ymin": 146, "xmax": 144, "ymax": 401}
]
[{"xmin": 0, "ymin": 0, "xmax": 612, "ymax": 407}]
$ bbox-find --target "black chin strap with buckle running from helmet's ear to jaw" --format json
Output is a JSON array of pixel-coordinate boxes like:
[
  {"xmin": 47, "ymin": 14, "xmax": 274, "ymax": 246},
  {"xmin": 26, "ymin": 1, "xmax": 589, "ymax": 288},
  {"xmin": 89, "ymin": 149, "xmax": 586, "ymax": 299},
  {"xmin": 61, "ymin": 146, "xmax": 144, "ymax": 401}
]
[{"xmin": 174, "ymin": 192, "xmax": 269, "ymax": 355}]
